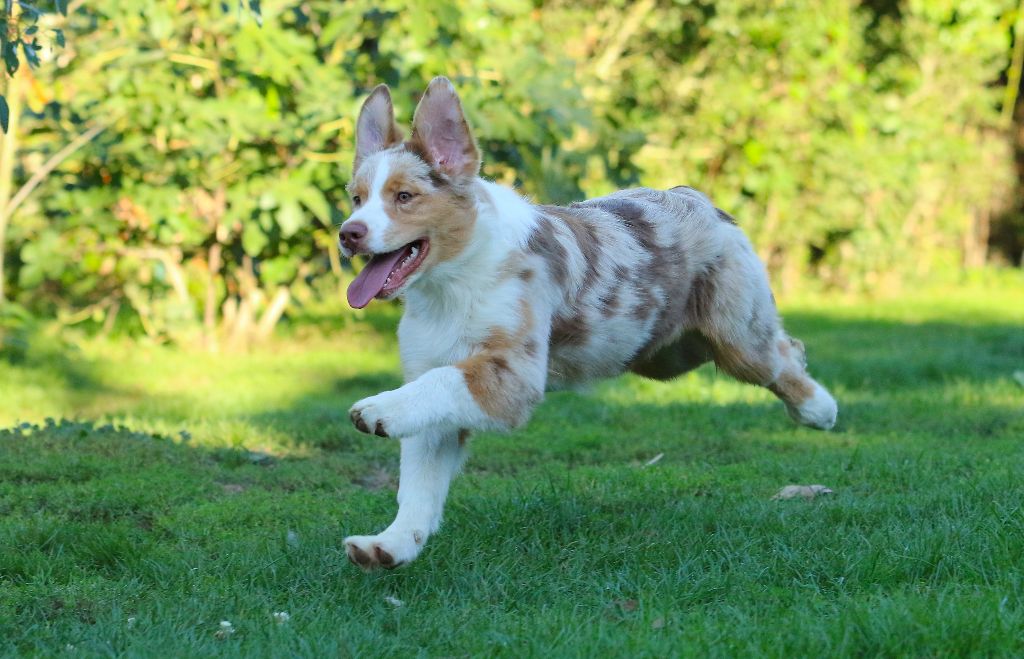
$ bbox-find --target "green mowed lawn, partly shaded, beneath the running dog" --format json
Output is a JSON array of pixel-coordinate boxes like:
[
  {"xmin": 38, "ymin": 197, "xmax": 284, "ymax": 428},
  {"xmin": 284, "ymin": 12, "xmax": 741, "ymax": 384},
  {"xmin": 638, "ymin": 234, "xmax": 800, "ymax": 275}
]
[{"xmin": 0, "ymin": 278, "xmax": 1024, "ymax": 657}]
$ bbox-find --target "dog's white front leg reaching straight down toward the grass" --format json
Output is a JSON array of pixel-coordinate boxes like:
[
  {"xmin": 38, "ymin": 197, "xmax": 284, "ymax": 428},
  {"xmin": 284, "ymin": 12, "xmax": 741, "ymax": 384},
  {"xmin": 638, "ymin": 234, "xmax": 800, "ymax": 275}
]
[{"xmin": 345, "ymin": 432, "xmax": 468, "ymax": 570}]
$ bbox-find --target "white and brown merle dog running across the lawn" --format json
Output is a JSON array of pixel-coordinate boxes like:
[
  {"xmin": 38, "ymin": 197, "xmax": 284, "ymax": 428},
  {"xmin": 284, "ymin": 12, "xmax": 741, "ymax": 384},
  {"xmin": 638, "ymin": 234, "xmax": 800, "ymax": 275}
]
[{"xmin": 341, "ymin": 78, "xmax": 837, "ymax": 569}]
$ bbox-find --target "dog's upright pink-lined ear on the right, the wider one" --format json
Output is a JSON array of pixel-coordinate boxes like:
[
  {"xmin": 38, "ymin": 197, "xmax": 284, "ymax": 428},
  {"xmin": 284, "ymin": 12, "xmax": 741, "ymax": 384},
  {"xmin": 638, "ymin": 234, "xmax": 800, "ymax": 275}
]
[{"xmin": 411, "ymin": 76, "xmax": 480, "ymax": 176}]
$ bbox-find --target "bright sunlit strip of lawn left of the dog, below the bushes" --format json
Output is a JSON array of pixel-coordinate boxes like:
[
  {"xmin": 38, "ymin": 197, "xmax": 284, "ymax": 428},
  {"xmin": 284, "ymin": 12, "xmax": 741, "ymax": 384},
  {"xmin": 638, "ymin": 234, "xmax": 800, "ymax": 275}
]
[{"xmin": 0, "ymin": 331, "xmax": 398, "ymax": 423}]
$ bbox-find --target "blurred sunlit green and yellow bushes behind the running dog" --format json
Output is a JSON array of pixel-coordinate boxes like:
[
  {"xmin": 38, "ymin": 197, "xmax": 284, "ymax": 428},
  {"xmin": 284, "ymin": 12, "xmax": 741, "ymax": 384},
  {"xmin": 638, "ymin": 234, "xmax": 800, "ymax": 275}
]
[{"xmin": 0, "ymin": 0, "xmax": 1024, "ymax": 347}]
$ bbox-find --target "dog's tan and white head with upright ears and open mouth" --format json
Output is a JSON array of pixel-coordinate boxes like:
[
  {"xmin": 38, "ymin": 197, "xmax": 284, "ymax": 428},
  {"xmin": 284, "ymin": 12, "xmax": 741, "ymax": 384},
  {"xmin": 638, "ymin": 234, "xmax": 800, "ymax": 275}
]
[{"xmin": 339, "ymin": 78, "xmax": 480, "ymax": 308}]
